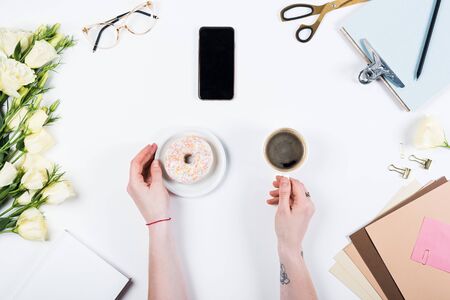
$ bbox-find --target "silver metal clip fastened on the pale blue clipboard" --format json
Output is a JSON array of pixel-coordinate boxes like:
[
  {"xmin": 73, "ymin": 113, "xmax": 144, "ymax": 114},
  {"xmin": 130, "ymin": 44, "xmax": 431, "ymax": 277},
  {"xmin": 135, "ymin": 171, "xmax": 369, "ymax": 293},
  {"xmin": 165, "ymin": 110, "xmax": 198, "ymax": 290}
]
[{"xmin": 358, "ymin": 39, "xmax": 405, "ymax": 88}]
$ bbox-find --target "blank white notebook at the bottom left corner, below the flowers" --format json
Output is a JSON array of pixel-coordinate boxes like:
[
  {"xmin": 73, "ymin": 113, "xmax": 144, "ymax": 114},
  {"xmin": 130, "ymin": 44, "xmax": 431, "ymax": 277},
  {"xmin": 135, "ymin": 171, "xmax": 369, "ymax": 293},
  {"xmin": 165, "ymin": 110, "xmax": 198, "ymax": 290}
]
[{"xmin": 13, "ymin": 231, "xmax": 131, "ymax": 300}]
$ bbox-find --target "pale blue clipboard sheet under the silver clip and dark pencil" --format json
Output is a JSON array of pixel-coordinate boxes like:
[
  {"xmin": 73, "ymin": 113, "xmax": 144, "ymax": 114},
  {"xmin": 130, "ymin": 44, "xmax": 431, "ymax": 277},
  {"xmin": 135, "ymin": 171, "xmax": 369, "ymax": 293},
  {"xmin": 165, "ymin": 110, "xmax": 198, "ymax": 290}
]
[{"xmin": 342, "ymin": 0, "xmax": 450, "ymax": 110}]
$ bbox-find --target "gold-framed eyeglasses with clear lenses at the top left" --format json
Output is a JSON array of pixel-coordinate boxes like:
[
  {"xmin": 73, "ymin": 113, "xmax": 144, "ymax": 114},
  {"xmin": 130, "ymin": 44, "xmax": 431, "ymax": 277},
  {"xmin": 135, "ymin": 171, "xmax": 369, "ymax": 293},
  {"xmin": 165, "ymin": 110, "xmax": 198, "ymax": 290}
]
[{"xmin": 82, "ymin": 1, "xmax": 159, "ymax": 52}]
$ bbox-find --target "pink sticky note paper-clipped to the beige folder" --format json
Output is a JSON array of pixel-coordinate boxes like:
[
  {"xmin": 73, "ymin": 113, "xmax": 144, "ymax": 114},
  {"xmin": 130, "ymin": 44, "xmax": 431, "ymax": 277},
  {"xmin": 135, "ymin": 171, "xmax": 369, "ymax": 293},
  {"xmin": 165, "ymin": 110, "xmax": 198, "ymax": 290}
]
[{"xmin": 411, "ymin": 218, "xmax": 450, "ymax": 273}]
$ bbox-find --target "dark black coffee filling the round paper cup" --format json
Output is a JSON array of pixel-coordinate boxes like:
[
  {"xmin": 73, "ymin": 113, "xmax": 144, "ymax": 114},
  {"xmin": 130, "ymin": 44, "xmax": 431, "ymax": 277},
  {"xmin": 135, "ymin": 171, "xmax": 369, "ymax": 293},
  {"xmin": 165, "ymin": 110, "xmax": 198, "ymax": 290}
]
[{"xmin": 266, "ymin": 131, "xmax": 305, "ymax": 170}]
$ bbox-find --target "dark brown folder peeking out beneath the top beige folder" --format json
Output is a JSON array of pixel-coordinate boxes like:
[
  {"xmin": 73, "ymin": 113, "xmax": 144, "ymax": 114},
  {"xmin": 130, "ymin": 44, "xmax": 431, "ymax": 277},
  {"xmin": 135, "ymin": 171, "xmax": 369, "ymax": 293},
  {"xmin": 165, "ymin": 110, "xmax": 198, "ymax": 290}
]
[{"xmin": 350, "ymin": 177, "xmax": 447, "ymax": 300}]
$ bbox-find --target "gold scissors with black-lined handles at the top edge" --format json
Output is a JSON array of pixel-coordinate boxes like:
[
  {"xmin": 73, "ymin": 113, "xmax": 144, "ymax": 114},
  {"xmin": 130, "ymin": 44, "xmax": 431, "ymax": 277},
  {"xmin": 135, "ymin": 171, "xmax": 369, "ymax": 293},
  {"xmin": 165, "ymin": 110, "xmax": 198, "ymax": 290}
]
[{"xmin": 280, "ymin": 0, "xmax": 368, "ymax": 43}]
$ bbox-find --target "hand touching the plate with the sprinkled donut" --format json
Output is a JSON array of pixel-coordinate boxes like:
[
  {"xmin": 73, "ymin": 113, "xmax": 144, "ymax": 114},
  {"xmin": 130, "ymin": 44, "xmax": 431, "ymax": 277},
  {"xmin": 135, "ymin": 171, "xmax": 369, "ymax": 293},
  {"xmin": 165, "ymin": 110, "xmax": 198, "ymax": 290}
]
[{"xmin": 127, "ymin": 144, "xmax": 169, "ymax": 223}]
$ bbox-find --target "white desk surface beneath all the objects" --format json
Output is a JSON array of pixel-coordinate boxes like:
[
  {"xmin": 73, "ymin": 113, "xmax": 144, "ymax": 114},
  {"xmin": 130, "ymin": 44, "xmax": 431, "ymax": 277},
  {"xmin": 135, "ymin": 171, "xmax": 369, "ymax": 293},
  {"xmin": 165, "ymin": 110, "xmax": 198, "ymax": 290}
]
[{"xmin": 0, "ymin": 0, "xmax": 450, "ymax": 300}]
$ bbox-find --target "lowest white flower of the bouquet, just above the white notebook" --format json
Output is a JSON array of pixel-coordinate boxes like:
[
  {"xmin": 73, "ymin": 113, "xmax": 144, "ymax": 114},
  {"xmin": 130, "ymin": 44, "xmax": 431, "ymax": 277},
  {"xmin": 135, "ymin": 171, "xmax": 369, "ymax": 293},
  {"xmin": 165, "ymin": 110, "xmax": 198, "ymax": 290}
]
[{"xmin": 14, "ymin": 207, "xmax": 47, "ymax": 241}]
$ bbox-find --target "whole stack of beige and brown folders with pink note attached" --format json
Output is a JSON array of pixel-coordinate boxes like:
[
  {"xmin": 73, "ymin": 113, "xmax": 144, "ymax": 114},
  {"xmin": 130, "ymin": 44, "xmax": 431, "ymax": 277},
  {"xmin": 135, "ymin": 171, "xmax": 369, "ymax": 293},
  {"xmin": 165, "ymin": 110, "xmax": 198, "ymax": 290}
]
[{"xmin": 330, "ymin": 177, "xmax": 450, "ymax": 300}]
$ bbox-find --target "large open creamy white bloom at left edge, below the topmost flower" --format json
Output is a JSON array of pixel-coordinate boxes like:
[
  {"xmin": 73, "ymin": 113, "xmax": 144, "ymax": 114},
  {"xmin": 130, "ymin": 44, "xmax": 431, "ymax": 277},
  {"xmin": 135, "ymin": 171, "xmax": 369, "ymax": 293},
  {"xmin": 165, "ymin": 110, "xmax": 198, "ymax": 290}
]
[{"xmin": 0, "ymin": 57, "xmax": 36, "ymax": 97}]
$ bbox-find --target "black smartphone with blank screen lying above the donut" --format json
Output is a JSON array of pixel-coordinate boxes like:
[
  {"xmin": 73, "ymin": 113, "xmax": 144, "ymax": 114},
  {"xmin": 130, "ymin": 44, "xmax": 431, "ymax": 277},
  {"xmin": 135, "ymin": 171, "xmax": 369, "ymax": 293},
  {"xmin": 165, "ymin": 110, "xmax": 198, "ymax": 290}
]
[{"xmin": 199, "ymin": 27, "xmax": 234, "ymax": 100}]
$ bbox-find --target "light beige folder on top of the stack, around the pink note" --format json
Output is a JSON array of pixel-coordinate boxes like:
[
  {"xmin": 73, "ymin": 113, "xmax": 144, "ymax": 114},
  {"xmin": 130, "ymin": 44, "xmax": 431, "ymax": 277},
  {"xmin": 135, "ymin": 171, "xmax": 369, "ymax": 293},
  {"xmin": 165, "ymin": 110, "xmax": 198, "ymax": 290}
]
[{"xmin": 366, "ymin": 182, "xmax": 450, "ymax": 300}]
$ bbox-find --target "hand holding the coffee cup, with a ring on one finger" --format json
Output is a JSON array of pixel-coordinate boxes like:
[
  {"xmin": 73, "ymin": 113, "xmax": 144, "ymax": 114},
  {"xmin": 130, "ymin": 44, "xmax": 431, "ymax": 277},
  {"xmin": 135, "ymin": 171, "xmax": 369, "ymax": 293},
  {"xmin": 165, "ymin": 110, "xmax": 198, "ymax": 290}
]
[{"xmin": 267, "ymin": 176, "xmax": 315, "ymax": 255}]
